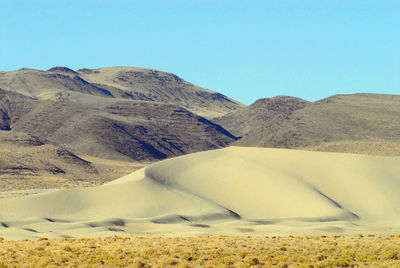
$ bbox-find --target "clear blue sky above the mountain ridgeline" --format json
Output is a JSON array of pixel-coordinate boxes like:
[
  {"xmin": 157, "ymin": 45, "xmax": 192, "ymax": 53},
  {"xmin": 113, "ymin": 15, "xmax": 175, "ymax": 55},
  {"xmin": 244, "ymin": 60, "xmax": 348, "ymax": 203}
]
[{"xmin": 0, "ymin": 0, "xmax": 400, "ymax": 104}]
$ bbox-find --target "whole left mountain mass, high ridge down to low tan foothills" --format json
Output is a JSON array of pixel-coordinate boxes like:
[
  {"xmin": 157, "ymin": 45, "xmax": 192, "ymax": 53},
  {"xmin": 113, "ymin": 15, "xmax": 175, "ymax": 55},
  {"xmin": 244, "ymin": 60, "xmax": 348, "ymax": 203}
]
[{"xmin": 0, "ymin": 67, "xmax": 244, "ymax": 190}]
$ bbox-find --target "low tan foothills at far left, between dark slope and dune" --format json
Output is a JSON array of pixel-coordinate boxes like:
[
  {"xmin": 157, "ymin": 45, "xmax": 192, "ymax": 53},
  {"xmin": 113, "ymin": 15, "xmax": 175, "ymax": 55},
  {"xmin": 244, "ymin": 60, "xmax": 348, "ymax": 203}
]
[{"xmin": 0, "ymin": 131, "xmax": 147, "ymax": 191}]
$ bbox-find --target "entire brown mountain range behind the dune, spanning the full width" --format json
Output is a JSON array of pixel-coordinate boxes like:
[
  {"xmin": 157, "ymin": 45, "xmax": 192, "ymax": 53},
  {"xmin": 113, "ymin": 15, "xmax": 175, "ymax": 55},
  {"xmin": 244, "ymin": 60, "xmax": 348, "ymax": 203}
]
[{"xmin": 0, "ymin": 64, "xmax": 400, "ymax": 190}]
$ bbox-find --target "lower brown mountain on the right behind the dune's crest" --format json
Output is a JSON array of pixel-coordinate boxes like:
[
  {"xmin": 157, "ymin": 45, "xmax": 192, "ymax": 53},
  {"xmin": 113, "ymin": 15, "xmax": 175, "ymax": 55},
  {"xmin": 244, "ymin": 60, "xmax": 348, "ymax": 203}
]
[{"xmin": 214, "ymin": 94, "xmax": 400, "ymax": 155}]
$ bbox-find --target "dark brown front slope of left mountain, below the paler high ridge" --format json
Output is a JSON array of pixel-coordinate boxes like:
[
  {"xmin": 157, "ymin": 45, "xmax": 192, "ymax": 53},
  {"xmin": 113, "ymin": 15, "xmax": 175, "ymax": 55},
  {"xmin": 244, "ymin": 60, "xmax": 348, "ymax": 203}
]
[{"xmin": 0, "ymin": 90, "xmax": 235, "ymax": 161}]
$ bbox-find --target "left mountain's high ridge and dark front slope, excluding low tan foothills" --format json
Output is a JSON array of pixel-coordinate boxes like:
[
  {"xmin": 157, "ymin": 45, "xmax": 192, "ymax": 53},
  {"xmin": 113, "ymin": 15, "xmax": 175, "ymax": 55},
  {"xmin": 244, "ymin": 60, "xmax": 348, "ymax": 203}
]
[{"xmin": 0, "ymin": 67, "xmax": 244, "ymax": 161}]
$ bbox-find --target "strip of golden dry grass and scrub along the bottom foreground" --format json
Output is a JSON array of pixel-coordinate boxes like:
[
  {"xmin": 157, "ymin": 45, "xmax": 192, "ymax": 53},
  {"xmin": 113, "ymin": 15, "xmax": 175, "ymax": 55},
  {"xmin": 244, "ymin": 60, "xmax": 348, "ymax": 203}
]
[{"xmin": 0, "ymin": 236, "xmax": 400, "ymax": 267}]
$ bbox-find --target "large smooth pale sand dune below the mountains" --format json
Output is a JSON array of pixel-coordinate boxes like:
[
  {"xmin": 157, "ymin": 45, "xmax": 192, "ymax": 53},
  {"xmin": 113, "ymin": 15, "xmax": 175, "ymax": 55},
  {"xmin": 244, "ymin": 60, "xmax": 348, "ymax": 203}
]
[{"xmin": 0, "ymin": 147, "xmax": 400, "ymax": 239}]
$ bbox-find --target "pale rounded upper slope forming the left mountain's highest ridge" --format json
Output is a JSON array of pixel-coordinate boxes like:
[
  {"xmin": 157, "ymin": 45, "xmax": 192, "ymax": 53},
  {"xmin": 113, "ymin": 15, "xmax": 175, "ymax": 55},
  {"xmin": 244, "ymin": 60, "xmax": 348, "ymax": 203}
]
[{"xmin": 78, "ymin": 67, "xmax": 244, "ymax": 117}]
